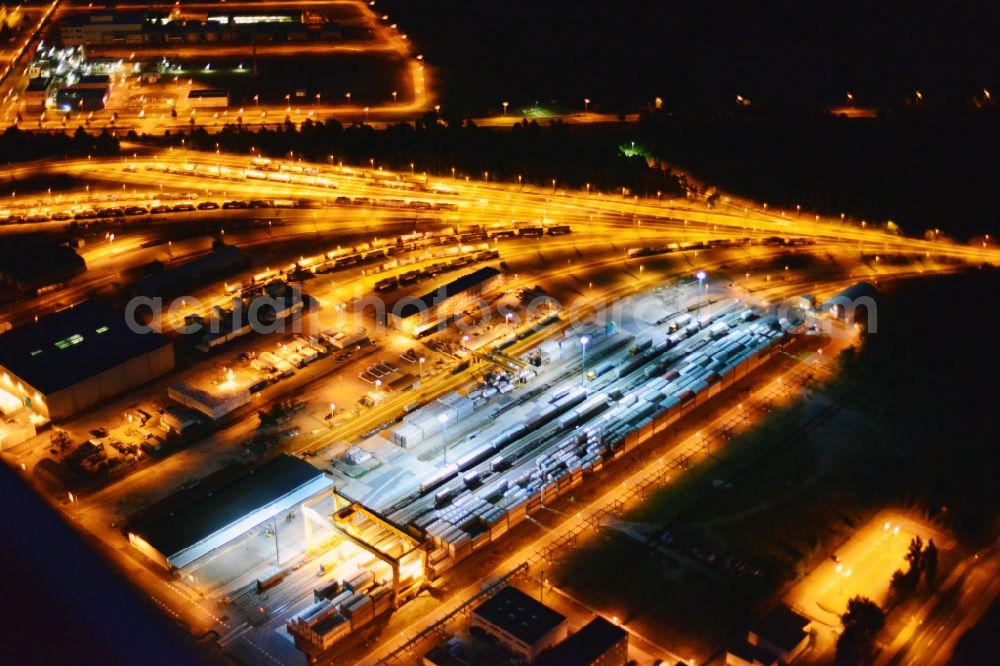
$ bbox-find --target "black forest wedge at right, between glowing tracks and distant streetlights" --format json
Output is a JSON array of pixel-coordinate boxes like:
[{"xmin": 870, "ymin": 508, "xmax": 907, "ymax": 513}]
[{"xmin": 636, "ymin": 107, "xmax": 1000, "ymax": 243}]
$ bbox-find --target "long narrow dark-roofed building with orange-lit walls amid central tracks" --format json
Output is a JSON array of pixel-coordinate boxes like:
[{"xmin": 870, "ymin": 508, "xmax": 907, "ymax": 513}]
[{"xmin": 386, "ymin": 266, "xmax": 503, "ymax": 335}]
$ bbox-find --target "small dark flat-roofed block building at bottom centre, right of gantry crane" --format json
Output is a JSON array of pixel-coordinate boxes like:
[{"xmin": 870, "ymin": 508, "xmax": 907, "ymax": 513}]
[{"xmin": 471, "ymin": 586, "xmax": 566, "ymax": 663}]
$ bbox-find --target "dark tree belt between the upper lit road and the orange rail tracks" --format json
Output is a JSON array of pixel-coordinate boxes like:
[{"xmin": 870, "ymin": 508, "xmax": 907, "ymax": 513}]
[{"xmin": 130, "ymin": 113, "xmax": 685, "ymax": 197}]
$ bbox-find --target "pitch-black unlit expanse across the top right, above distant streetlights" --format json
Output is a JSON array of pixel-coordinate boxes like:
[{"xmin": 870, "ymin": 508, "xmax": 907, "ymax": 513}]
[{"xmin": 378, "ymin": 0, "xmax": 1000, "ymax": 113}]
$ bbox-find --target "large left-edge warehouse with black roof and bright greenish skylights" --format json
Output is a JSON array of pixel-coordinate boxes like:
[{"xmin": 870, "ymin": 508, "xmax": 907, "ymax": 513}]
[{"xmin": 0, "ymin": 301, "xmax": 174, "ymax": 420}]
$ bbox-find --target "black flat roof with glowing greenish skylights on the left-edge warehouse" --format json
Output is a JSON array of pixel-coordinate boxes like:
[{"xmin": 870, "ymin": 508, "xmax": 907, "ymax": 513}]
[{"xmin": 0, "ymin": 301, "xmax": 171, "ymax": 394}]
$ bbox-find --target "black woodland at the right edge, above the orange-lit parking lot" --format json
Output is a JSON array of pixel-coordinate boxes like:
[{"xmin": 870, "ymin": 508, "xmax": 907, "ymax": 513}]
[{"xmin": 844, "ymin": 267, "xmax": 1000, "ymax": 540}]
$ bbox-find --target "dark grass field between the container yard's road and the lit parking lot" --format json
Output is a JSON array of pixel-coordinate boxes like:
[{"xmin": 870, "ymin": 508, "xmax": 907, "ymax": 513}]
[{"xmin": 554, "ymin": 374, "xmax": 904, "ymax": 655}]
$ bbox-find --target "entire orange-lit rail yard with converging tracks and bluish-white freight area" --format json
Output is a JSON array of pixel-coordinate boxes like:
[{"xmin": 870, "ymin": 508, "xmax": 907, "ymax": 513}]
[{"xmin": 0, "ymin": 149, "xmax": 997, "ymax": 663}]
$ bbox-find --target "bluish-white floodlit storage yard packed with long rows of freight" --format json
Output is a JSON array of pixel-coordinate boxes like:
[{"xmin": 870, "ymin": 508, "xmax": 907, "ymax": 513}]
[{"xmin": 375, "ymin": 303, "xmax": 791, "ymax": 577}]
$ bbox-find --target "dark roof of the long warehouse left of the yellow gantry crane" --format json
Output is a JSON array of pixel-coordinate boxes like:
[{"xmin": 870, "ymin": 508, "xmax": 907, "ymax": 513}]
[{"xmin": 131, "ymin": 454, "xmax": 332, "ymax": 566}]
